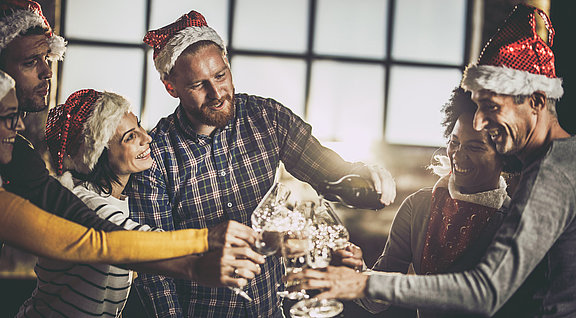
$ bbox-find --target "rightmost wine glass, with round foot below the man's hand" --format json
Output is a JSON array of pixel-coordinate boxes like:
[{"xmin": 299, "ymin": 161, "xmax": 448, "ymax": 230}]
[{"xmin": 290, "ymin": 199, "xmax": 349, "ymax": 318}]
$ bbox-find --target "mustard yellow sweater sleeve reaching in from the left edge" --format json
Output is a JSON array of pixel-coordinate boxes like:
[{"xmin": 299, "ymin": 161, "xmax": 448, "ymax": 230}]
[{"xmin": 0, "ymin": 188, "xmax": 208, "ymax": 264}]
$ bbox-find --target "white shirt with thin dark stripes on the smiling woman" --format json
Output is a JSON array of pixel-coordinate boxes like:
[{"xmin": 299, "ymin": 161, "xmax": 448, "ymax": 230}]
[{"xmin": 17, "ymin": 179, "xmax": 155, "ymax": 318}]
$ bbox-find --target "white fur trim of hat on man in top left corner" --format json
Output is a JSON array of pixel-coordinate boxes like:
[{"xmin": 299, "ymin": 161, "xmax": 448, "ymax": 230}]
[{"xmin": 0, "ymin": 10, "xmax": 66, "ymax": 61}]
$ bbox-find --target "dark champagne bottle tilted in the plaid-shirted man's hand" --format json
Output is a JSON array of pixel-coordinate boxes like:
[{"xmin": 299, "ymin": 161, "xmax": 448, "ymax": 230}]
[{"xmin": 318, "ymin": 174, "xmax": 386, "ymax": 210}]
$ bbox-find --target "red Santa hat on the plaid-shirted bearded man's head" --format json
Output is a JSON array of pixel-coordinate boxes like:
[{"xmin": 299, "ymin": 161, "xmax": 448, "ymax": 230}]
[{"xmin": 144, "ymin": 11, "xmax": 226, "ymax": 80}]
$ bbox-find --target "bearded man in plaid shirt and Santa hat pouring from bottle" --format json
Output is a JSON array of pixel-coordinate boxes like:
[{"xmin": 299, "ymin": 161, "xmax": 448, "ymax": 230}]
[{"xmin": 128, "ymin": 11, "xmax": 396, "ymax": 317}]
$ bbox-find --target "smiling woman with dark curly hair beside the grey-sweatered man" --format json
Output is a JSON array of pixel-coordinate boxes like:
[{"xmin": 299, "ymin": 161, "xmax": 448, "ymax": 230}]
[{"xmin": 352, "ymin": 88, "xmax": 510, "ymax": 317}]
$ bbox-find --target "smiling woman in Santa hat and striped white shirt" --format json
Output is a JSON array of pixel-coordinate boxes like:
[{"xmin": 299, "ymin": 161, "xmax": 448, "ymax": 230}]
[{"xmin": 20, "ymin": 89, "xmax": 164, "ymax": 317}]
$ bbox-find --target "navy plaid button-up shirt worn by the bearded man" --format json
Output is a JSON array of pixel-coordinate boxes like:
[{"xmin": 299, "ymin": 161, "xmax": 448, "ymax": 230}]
[{"xmin": 128, "ymin": 94, "xmax": 360, "ymax": 317}]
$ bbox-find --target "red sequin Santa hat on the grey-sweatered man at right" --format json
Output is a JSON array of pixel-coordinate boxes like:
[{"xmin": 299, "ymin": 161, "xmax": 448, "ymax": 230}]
[{"xmin": 461, "ymin": 4, "xmax": 564, "ymax": 99}]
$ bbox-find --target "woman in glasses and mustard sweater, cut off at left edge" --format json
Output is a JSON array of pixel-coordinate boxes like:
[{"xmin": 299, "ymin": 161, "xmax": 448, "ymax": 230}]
[{"xmin": 0, "ymin": 71, "xmax": 263, "ymax": 286}]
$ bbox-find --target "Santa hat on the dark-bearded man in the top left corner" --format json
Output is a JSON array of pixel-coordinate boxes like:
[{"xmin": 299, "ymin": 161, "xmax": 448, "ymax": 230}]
[{"xmin": 0, "ymin": 0, "xmax": 66, "ymax": 61}]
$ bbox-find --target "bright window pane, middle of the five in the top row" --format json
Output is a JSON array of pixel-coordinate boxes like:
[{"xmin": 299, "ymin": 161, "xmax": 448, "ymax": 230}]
[{"xmin": 232, "ymin": 0, "xmax": 308, "ymax": 53}]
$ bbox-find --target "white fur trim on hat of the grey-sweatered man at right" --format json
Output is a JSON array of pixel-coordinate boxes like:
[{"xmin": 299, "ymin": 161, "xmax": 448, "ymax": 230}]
[{"xmin": 460, "ymin": 64, "xmax": 564, "ymax": 99}]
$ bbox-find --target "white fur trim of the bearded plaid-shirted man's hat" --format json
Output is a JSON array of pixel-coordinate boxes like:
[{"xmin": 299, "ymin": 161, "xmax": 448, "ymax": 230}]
[{"xmin": 154, "ymin": 26, "xmax": 226, "ymax": 80}]
